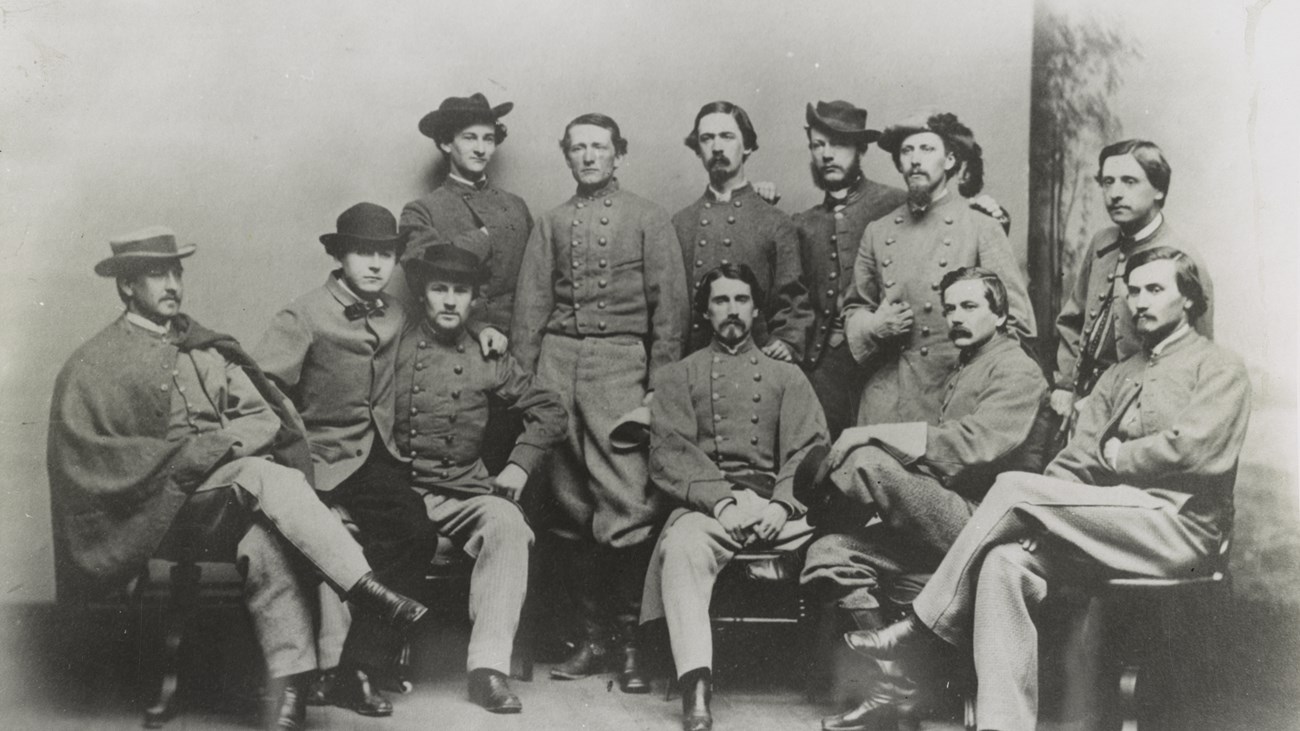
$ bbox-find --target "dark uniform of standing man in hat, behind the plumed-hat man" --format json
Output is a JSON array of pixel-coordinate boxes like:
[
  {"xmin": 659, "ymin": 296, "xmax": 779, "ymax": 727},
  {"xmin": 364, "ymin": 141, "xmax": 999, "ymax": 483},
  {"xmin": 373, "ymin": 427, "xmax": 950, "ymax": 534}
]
[{"xmin": 794, "ymin": 177, "xmax": 907, "ymax": 440}]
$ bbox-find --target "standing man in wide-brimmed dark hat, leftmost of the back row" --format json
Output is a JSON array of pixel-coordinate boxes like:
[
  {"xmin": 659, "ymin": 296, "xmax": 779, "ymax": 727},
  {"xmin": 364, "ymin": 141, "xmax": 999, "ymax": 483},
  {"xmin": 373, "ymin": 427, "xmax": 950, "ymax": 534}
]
[{"xmin": 399, "ymin": 92, "xmax": 533, "ymax": 364}]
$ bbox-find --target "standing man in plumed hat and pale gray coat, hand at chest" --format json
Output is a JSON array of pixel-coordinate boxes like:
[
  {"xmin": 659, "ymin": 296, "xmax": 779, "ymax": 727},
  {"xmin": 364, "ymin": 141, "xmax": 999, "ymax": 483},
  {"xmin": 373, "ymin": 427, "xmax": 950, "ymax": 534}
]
[{"xmin": 844, "ymin": 113, "xmax": 1035, "ymax": 424}]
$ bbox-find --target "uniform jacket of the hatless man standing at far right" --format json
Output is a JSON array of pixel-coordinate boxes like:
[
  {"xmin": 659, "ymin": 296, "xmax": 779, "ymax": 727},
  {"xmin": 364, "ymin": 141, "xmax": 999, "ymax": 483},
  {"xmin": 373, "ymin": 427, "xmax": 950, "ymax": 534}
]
[{"xmin": 1053, "ymin": 215, "xmax": 1214, "ymax": 395}]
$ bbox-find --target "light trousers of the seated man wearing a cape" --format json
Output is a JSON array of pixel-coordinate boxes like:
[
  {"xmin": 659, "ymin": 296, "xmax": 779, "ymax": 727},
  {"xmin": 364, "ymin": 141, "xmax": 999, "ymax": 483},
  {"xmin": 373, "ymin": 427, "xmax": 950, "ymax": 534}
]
[{"xmin": 177, "ymin": 457, "xmax": 371, "ymax": 678}]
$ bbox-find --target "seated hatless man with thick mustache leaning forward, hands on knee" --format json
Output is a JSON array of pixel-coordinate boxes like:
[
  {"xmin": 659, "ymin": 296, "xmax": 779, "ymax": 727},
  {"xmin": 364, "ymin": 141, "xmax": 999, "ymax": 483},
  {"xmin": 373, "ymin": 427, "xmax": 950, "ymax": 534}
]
[{"xmin": 794, "ymin": 267, "xmax": 1047, "ymax": 731}]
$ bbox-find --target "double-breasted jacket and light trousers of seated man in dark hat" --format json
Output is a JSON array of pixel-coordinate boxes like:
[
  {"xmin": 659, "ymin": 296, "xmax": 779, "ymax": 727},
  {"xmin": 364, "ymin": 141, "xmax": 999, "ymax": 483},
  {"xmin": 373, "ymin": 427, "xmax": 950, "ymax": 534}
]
[{"xmin": 394, "ymin": 320, "xmax": 566, "ymax": 674}]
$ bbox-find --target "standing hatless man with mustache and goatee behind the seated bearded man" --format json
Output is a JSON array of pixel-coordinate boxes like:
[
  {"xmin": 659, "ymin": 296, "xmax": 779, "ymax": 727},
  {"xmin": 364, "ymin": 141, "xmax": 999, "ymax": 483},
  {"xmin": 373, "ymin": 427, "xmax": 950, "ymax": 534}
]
[{"xmin": 672, "ymin": 101, "xmax": 813, "ymax": 363}]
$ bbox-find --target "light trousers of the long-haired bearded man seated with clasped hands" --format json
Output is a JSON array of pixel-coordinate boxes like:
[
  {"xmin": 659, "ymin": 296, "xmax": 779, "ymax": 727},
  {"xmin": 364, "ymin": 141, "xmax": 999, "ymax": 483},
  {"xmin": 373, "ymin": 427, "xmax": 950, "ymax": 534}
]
[{"xmin": 641, "ymin": 489, "xmax": 813, "ymax": 675}]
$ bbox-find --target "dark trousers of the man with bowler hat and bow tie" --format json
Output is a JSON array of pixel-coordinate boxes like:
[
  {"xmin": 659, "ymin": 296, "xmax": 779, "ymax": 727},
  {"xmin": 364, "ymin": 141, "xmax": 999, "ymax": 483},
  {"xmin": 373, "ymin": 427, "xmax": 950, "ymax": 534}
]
[{"xmin": 324, "ymin": 445, "xmax": 438, "ymax": 671}]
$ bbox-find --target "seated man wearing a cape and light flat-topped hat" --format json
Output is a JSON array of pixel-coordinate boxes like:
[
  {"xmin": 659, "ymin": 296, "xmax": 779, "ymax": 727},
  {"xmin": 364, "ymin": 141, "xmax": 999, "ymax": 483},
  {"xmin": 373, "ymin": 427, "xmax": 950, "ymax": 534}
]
[{"xmin": 48, "ymin": 226, "xmax": 426, "ymax": 728}]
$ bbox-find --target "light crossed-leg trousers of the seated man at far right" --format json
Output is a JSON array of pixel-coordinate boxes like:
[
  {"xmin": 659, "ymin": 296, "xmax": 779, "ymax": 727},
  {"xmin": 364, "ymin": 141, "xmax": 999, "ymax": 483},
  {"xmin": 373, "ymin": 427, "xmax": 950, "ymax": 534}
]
[{"xmin": 913, "ymin": 472, "xmax": 1218, "ymax": 731}]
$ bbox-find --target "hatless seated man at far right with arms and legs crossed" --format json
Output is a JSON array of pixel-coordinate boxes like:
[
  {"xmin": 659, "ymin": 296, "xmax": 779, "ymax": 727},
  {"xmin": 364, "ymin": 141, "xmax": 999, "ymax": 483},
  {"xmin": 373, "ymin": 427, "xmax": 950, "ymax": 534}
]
[{"xmin": 845, "ymin": 246, "xmax": 1251, "ymax": 731}]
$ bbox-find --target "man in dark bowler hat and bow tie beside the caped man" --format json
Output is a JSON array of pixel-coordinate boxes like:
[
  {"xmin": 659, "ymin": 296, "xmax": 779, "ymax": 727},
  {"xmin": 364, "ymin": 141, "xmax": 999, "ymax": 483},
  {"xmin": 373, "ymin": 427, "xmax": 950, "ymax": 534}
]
[{"xmin": 252, "ymin": 203, "xmax": 436, "ymax": 715}]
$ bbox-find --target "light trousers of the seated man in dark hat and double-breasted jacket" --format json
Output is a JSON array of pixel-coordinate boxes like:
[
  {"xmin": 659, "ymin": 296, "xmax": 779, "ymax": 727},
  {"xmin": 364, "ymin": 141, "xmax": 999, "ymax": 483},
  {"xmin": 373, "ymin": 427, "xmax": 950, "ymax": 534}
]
[{"xmin": 421, "ymin": 490, "xmax": 533, "ymax": 675}]
